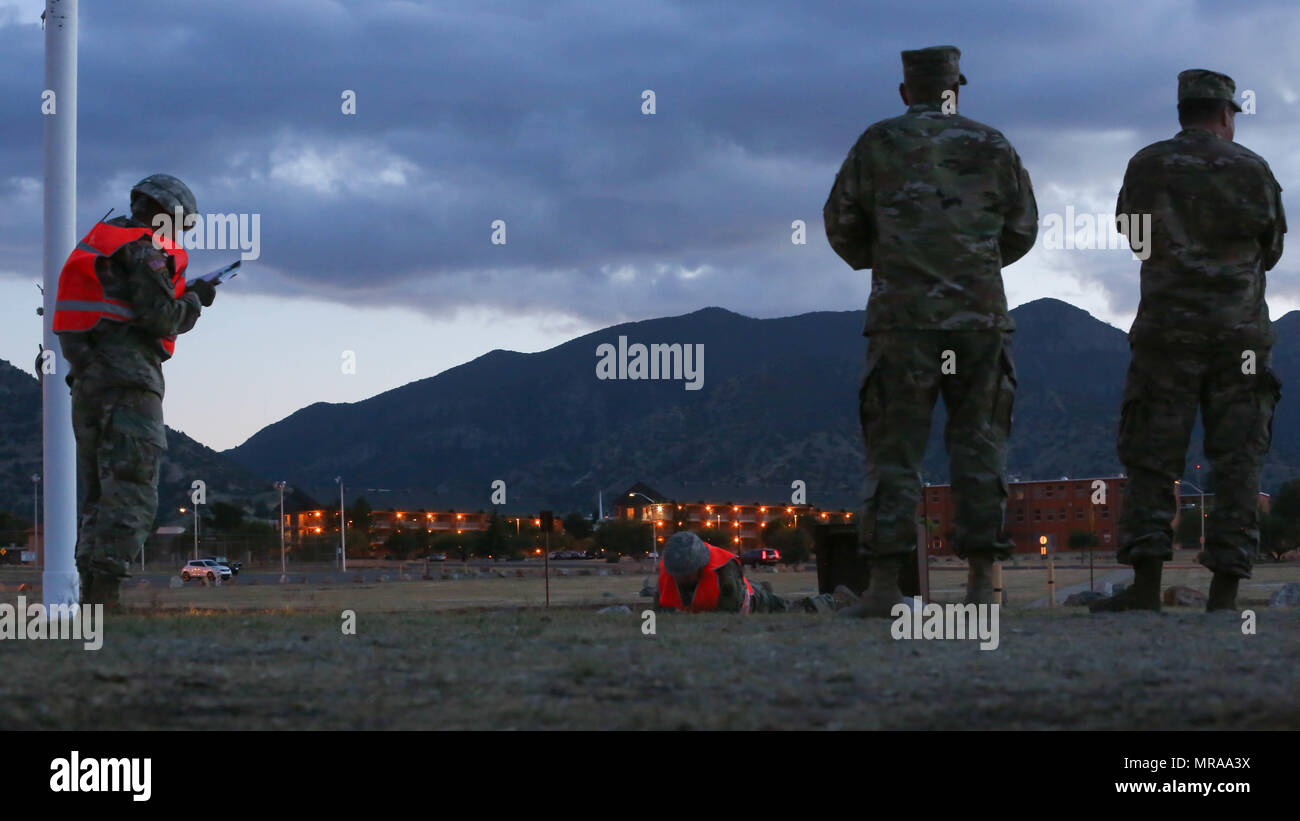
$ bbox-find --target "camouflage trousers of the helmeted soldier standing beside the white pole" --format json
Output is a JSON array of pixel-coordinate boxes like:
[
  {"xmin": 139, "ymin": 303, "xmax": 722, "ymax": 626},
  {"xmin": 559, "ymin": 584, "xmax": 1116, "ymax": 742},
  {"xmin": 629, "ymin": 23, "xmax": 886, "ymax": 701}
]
[{"xmin": 73, "ymin": 379, "xmax": 166, "ymax": 575}]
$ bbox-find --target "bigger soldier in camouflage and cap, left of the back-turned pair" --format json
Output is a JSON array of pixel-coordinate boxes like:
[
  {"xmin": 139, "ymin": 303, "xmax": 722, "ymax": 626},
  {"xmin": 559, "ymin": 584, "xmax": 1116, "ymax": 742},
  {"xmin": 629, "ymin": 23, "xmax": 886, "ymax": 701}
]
[{"xmin": 823, "ymin": 45, "xmax": 1037, "ymax": 616}]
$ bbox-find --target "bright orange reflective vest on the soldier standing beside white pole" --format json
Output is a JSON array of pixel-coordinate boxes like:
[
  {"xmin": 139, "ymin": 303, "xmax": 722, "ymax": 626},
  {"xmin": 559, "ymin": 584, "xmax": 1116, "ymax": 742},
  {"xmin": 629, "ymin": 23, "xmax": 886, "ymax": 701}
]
[{"xmin": 53, "ymin": 222, "xmax": 190, "ymax": 360}]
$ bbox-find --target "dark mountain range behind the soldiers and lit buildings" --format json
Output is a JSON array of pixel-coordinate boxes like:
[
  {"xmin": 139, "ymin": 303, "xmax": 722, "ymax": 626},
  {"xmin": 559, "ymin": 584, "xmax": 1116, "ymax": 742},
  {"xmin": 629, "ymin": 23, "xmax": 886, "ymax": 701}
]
[{"xmin": 0, "ymin": 299, "xmax": 1300, "ymax": 522}]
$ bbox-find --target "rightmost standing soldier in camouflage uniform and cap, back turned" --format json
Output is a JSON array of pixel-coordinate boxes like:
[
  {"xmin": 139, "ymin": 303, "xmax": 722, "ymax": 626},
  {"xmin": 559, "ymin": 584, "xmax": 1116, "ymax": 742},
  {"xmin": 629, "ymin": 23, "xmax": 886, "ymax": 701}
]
[{"xmin": 1092, "ymin": 69, "xmax": 1287, "ymax": 611}]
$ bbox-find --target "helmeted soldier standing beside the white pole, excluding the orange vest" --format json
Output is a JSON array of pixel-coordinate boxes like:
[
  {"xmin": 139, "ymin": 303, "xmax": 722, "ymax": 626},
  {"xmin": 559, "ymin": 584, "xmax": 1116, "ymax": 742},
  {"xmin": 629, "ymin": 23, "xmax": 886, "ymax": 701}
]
[{"xmin": 59, "ymin": 174, "xmax": 215, "ymax": 607}]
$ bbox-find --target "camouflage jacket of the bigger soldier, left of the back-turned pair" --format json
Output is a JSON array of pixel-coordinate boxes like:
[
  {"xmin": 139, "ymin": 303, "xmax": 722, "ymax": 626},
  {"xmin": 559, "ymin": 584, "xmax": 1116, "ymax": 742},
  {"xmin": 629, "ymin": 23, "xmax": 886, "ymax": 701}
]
[{"xmin": 822, "ymin": 103, "xmax": 1039, "ymax": 334}]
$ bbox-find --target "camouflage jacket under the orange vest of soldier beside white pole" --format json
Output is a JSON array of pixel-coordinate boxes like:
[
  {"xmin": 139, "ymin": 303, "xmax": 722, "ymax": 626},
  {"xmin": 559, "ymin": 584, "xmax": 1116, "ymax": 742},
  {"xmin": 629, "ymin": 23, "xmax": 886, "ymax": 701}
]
[{"xmin": 59, "ymin": 217, "xmax": 202, "ymax": 398}]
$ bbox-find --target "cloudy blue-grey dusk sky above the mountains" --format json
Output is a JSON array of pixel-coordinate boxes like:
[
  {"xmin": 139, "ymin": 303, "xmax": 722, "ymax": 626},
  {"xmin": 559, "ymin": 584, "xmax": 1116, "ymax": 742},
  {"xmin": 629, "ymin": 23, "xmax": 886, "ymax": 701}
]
[{"xmin": 0, "ymin": 0, "xmax": 1300, "ymax": 449}]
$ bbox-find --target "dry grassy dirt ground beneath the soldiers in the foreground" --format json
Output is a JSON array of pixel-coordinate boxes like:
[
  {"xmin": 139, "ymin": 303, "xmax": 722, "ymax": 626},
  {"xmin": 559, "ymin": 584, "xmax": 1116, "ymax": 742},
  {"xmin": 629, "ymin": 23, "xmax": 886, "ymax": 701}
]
[{"xmin": 0, "ymin": 565, "xmax": 1300, "ymax": 730}]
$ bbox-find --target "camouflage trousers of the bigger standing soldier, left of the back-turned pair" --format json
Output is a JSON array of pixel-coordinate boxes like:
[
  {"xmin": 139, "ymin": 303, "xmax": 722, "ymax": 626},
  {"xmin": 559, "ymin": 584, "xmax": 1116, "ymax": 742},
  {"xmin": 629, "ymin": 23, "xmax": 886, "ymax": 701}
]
[{"xmin": 858, "ymin": 330, "xmax": 1015, "ymax": 559}]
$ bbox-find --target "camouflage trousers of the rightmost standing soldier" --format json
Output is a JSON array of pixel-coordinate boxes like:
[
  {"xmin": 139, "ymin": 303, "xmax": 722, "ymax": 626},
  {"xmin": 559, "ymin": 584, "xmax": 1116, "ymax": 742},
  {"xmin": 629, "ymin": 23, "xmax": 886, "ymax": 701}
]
[{"xmin": 1118, "ymin": 346, "xmax": 1282, "ymax": 578}]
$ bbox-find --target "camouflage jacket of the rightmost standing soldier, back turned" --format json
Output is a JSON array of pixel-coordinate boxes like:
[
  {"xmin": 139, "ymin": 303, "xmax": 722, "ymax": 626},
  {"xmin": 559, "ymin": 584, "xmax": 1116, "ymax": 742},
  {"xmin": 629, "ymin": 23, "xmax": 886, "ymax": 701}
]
[{"xmin": 1115, "ymin": 129, "xmax": 1287, "ymax": 348}]
